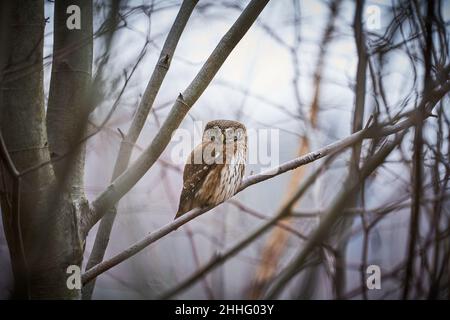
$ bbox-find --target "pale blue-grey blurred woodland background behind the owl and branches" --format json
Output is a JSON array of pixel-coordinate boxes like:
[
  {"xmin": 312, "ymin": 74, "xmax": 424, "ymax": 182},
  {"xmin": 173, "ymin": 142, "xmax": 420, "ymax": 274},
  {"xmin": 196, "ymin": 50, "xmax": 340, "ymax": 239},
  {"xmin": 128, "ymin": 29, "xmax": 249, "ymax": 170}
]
[{"xmin": 0, "ymin": 0, "xmax": 450, "ymax": 299}]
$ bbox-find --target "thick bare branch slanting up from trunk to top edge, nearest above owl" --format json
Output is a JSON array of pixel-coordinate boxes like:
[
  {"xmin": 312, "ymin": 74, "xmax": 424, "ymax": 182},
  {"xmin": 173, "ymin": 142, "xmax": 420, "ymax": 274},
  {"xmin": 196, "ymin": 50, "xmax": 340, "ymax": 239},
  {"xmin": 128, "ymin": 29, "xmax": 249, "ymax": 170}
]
[{"xmin": 81, "ymin": 0, "xmax": 269, "ymax": 234}]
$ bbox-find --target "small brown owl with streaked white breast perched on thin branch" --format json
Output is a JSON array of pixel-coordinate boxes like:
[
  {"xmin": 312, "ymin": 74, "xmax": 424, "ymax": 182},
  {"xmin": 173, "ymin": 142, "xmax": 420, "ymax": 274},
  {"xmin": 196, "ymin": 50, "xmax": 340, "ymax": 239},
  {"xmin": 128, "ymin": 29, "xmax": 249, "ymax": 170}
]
[{"xmin": 175, "ymin": 120, "xmax": 247, "ymax": 219}]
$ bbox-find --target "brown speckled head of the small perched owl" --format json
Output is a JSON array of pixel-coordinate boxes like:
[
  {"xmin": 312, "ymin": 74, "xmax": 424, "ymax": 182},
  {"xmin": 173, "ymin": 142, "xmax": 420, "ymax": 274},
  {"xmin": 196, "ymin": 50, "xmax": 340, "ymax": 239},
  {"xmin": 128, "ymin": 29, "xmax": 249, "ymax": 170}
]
[{"xmin": 203, "ymin": 120, "xmax": 247, "ymax": 144}]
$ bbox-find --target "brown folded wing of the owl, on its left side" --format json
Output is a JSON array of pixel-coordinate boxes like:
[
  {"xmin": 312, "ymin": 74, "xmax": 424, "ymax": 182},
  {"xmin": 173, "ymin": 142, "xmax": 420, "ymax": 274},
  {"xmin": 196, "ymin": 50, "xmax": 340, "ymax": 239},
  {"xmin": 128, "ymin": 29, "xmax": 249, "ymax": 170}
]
[{"xmin": 175, "ymin": 142, "xmax": 218, "ymax": 219}]
